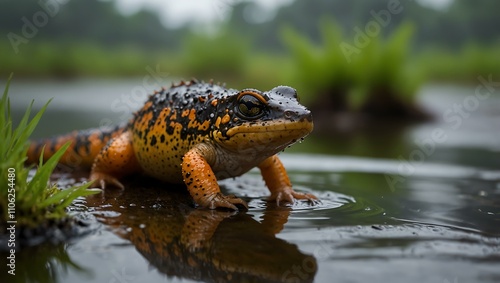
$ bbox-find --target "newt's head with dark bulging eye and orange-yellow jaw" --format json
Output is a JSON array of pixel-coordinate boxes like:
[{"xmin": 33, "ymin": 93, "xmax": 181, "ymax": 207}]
[{"xmin": 214, "ymin": 86, "xmax": 313, "ymax": 155}]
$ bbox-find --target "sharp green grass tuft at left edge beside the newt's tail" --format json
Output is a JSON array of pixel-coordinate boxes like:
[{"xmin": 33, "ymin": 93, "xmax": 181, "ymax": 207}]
[{"xmin": 0, "ymin": 75, "xmax": 100, "ymax": 227}]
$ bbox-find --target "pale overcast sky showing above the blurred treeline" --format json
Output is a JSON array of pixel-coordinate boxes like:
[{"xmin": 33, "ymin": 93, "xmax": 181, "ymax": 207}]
[{"xmin": 113, "ymin": 0, "xmax": 453, "ymax": 27}]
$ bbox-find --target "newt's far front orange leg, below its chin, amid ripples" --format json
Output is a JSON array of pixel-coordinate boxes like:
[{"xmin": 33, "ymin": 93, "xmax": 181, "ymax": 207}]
[{"xmin": 259, "ymin": 155, "xmax": 318, "ymax": 205}]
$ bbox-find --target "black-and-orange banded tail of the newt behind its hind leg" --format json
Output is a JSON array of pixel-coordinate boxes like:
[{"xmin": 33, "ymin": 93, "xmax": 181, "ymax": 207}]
[{"xmin": 26, "ymin": 125, "xmax": 126, "ymax": 169}]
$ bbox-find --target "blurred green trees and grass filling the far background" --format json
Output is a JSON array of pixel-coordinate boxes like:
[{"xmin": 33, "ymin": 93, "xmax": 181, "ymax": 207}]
[{"xmin": 0, "ymin": 0, "xmax": 500, "ymax": 116}]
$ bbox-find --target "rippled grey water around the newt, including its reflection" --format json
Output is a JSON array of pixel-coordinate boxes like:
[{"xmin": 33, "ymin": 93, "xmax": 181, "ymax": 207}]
[{"xmin": 0, "ymin": 80, "xmax": 500, "ymax": 283}]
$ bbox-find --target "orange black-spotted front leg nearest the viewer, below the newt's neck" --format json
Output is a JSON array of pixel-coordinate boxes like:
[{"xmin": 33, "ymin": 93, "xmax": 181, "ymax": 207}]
[{"xmin": 182, "ymin": 148, "xmax": 248, "ymax": 210}]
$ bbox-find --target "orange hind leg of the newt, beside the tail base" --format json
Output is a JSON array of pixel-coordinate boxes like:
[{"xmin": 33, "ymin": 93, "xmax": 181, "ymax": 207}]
[{"xmin": 90, "ymin": 131, "xmax": 141, "ymax": 189}]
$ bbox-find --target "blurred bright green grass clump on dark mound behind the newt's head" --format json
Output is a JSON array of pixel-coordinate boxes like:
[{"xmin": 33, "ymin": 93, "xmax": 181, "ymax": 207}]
[{"xmin": 283, "ymin": 20, "xmax": 423, "ymax": 116}]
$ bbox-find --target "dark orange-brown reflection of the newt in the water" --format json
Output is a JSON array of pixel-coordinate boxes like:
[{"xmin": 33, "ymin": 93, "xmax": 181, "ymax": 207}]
[{"xmin": 88, "ymin": 181, "xmax": 317, "ymax": 282}]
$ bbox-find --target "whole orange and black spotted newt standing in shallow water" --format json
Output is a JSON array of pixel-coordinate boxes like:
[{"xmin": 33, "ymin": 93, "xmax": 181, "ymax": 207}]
[{"xmin": 28, "ymin": 80, "xmax": 317, "ymax": 210}]
